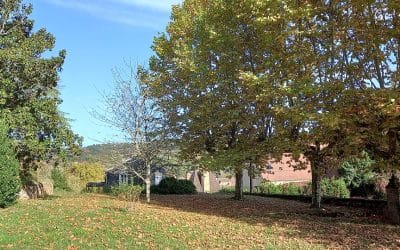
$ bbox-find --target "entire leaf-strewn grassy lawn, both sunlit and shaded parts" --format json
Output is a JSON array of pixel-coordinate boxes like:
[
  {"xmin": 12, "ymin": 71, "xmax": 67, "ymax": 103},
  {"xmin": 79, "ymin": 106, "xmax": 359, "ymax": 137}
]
[{"xmin": 0, "ymin": 194, "xmax": 400, "ymax": 249}]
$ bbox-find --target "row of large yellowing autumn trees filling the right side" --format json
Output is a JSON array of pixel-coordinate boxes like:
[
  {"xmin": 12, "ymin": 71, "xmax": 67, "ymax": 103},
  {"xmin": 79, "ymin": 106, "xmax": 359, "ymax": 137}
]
[{"xmin": 139, "ymin": 0, "xmax": 400, "ymax": 207}]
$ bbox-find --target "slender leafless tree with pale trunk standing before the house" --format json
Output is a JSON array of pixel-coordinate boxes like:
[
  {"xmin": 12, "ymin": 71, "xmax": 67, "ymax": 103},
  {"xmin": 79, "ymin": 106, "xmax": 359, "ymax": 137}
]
[{"xmin": 93, "ymin": 65, "xmax": 165, "ymax": 202}]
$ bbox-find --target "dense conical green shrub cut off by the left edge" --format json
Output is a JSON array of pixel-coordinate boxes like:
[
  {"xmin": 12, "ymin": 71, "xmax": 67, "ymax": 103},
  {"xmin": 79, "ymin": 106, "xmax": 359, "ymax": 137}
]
[{"xmin": 0, "ymin": 123, "xmax": 21, "ymax": 208}]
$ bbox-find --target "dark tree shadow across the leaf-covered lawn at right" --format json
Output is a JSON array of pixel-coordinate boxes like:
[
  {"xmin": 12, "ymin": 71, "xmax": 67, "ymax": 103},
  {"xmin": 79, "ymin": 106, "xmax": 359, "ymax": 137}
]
[{"xmin": 148, "ymin": 194, "xmax": 400, "ymax": 249}]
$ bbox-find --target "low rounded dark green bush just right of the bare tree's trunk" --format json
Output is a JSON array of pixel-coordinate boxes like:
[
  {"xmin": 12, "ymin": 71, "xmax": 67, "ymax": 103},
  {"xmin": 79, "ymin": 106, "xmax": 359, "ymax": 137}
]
[{"xmin": 151, "ymin": 177, "xmax": 196, "ymax": 194}]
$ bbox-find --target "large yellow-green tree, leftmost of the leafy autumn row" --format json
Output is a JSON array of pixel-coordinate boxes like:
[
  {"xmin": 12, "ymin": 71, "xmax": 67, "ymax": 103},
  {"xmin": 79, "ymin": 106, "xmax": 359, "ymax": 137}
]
[{"xmin": 149, "ymin": 0, "xmax": 278, "ymax": 199}]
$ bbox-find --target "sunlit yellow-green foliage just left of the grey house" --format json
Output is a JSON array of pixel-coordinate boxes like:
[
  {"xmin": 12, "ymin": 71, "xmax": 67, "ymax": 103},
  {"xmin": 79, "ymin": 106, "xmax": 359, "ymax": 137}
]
[{"xmin": 71, "ymin": 162, "xmax": 104, "ymax": 183}]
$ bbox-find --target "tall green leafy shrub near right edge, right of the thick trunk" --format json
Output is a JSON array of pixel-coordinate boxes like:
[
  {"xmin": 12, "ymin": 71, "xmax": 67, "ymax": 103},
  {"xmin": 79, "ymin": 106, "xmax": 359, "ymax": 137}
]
[{"xmin": 339, "ymin": 152, "xmax": 376, "ymax": 188}]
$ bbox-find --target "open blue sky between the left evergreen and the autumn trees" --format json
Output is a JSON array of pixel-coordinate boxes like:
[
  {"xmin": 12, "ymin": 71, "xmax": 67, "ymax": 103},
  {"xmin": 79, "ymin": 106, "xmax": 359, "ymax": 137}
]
[{"xmin": 29, "ymin": 0, "xmax": 181, "ymax": 146}]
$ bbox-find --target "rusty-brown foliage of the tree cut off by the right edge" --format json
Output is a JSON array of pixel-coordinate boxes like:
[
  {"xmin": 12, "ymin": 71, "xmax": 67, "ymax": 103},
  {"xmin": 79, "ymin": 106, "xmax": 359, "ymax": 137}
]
[{"xmin": 343, "ymin": 0, "xmax": 400, "ymax": 188}]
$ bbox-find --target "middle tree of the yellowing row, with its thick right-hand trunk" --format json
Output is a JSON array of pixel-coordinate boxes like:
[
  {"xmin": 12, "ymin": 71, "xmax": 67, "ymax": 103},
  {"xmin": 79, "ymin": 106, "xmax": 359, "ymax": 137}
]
[{"xmin": 255, "ymin": 1, "xmax": 354, "ymax": 208}]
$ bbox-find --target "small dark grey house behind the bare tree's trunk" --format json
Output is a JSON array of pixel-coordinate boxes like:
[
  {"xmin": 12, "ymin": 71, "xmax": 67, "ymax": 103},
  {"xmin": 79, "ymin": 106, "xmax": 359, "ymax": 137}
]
[{"xmin": 105, "ymin": 158, "xmax": 167, "ymax": 187}]
